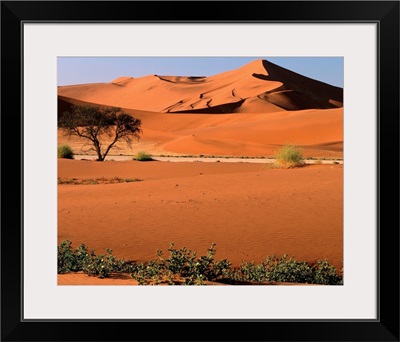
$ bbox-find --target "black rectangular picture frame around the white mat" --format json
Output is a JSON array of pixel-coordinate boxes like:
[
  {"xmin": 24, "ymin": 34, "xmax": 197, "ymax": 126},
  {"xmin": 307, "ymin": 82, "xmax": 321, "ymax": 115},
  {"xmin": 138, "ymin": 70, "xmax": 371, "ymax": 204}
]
[{"xmin": 1, "ymin": 1, "xmax": 400, "ymax": 341}]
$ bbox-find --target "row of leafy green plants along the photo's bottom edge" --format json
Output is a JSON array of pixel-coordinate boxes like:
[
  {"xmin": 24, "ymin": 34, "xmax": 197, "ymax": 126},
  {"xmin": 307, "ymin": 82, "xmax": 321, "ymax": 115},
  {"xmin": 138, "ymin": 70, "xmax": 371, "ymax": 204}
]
[{"xmin": 58, "ymin": 240, "xmax": 343, "ymax": 285}]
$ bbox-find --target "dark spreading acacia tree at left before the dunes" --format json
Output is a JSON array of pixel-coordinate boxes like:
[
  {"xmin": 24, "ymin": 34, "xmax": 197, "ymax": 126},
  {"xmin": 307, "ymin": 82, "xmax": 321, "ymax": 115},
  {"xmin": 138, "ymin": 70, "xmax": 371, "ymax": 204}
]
[{"xmin": 58, "ymin": 105, "xmax": 142, "ymax": 161}]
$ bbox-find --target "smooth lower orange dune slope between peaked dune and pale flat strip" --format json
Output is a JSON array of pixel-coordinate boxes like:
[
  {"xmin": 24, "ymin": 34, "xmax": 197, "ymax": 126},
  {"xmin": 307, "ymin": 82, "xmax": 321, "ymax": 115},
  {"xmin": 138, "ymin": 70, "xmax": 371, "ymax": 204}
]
[{"xmin": 59, "ymin": 97, "xmax": 343, "ymax": 158}]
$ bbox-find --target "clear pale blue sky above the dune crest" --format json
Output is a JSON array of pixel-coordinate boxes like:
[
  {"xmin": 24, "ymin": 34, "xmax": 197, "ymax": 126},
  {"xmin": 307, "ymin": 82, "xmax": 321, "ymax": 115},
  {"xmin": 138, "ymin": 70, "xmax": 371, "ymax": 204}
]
[{"xmin": 57, "ymin": 56, "xmax": 343, "ymax": 88}]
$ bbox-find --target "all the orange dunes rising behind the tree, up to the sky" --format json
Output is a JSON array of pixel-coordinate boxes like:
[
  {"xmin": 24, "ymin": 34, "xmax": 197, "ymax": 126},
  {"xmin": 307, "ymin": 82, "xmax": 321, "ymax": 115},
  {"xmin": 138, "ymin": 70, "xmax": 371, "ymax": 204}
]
[{"xmin": 58, "ymin": 60, "xmax": 343, "ymax": 158}]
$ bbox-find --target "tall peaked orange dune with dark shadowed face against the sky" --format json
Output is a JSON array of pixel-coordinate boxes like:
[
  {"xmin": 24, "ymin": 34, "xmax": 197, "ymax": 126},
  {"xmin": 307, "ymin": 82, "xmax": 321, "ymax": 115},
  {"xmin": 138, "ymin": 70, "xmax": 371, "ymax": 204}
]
[{"xmin": 58, "ymin": 60, "xmax": 343, "ymax": 113}]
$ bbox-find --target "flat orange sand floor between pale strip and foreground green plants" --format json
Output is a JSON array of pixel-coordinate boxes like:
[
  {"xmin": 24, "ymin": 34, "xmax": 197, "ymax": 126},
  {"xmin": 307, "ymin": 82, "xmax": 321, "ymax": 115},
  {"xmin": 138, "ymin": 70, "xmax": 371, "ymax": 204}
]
[{"xmin": 58, "ymin": 159, "xmax": 343, "ymax": 285}]
